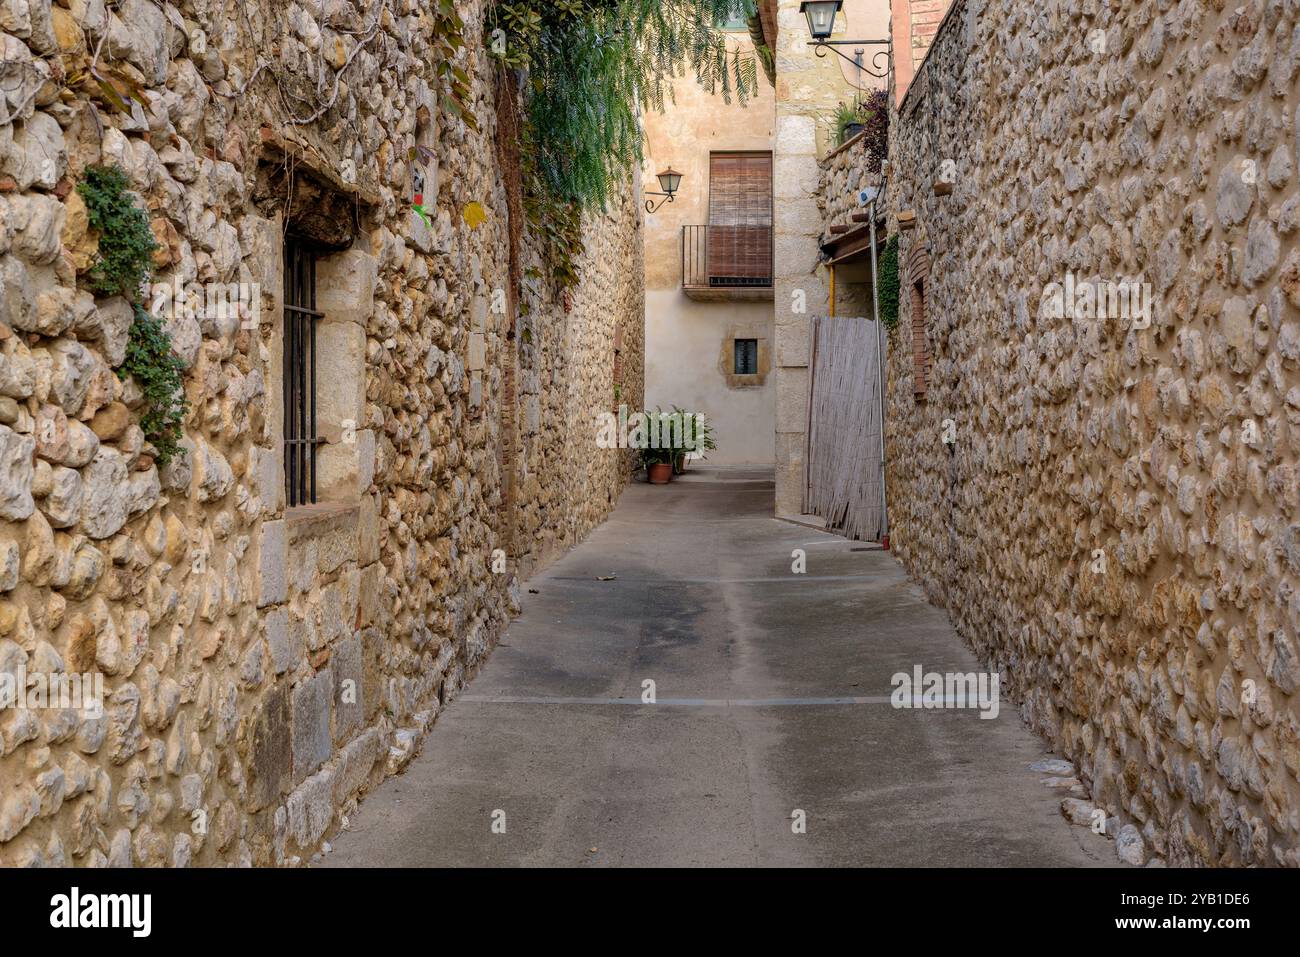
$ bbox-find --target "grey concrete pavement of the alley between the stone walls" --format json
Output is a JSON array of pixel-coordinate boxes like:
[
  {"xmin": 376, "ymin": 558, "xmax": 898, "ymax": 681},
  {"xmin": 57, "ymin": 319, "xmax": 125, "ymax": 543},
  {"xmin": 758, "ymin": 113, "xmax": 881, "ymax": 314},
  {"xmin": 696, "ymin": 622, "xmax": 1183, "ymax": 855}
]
[{"xmin": 320, "ymin": 469, "xmax": 1115, "ymax": 866}]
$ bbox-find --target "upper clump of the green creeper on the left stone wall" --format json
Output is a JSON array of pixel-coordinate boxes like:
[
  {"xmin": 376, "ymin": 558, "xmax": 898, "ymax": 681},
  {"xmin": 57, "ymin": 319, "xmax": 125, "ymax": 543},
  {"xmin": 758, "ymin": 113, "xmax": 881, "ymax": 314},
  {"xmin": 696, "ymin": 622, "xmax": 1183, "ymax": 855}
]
[{"xmin": 77, "ymin": 166, "xmax": 157, "ymax": 302}]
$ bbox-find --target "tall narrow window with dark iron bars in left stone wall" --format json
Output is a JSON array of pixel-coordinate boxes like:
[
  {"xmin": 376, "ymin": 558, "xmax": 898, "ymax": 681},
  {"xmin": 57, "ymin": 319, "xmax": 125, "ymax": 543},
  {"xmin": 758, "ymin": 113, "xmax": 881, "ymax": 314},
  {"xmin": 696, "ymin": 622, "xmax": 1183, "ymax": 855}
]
[{"xmin": 283, "ymin": 238, "xmax": 322, "ymax": 507}]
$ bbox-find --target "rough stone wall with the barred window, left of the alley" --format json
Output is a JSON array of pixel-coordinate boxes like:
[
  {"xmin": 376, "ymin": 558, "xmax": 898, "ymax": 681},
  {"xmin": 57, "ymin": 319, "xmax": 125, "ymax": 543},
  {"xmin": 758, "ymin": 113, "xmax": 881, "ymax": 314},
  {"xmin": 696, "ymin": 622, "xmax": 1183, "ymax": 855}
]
[{"xmin": 0, "ymin": 0, "xmax": 644, "ymax": 866}]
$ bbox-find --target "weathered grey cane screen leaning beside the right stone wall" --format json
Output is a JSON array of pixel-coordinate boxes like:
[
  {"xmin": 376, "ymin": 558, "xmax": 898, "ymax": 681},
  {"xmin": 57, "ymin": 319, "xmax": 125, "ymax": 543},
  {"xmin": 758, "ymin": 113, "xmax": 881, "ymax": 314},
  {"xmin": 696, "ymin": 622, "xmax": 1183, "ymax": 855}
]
[{"xmin": 803, "ymin": 316, "xmax": 884, "ymax": 541}]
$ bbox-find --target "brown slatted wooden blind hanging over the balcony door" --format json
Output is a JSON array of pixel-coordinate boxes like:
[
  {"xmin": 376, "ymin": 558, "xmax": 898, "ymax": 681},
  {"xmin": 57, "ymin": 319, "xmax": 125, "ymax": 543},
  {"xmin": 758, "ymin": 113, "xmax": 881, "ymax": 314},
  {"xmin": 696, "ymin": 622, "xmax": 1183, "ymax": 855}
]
[{"xmin": 709, "ymin": 153, "xmax": 772, "ymax": 285}]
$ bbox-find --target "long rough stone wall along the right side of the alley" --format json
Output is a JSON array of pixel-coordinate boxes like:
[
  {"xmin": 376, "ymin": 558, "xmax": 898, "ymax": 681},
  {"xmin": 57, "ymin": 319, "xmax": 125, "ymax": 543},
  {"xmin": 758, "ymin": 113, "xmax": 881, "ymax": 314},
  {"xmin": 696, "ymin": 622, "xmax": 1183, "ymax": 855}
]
[{"xmin": 887, "ymin": 0, "xmax": 1300, "ymax": 866}]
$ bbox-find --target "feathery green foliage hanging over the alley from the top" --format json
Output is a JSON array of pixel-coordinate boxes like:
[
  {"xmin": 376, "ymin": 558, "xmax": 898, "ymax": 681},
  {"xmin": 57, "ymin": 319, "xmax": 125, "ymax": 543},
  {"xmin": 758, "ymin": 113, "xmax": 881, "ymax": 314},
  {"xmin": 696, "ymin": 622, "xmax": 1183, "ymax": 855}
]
[{"xmin": 488, "ymin": 0, "xmax": 758, "ymax": 208}]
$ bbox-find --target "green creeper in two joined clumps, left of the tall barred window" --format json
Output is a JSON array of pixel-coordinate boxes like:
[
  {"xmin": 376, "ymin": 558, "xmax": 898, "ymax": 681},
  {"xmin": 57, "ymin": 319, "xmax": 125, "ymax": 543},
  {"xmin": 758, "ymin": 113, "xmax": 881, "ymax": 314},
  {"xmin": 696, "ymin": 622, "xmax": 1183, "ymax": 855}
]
[{"xmin": 77, "ymin": 166, "xmax": 189, "ymax": 465}]
